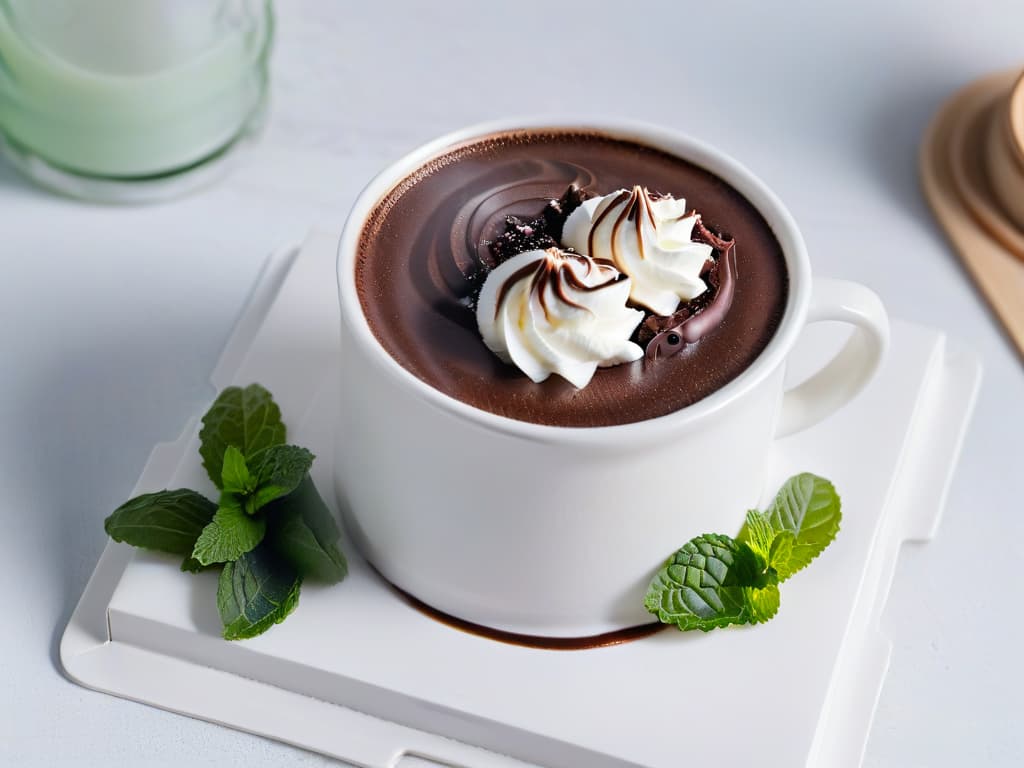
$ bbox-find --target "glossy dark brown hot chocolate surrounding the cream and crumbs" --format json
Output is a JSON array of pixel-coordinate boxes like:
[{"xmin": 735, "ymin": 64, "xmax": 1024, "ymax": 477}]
[{"xmin": 355, "ymin": 131, "xmax": 788, "ymax": 426}]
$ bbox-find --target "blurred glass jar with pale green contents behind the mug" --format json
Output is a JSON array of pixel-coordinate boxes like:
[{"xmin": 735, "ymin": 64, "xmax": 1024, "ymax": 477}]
[{"xmin": 0, "ymin": 0, "xmax": 273, "ymax": 202}]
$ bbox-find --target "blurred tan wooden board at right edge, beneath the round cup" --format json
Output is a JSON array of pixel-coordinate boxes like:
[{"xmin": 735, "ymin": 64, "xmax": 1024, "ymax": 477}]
[{"xmin": 920, "ymin": 71, "xmax": 1024, "ymax": 355}]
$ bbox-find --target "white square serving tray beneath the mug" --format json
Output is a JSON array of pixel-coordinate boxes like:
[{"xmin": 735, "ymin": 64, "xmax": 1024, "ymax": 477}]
[{"xmin": 60, "ymin": 233, "xmax": 980, "ymax": 768}]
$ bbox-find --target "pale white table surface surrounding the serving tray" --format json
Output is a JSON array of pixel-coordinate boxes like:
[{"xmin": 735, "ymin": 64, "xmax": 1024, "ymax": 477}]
[{"xmin": 0, "ymin": 0, "xmax": 1024, "ymax": 768}]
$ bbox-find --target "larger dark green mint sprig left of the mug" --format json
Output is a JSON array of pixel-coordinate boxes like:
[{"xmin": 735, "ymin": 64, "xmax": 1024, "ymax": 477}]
[{"xmin": 103, "ymin": 384, "xmax": 348, "ymax": 640}]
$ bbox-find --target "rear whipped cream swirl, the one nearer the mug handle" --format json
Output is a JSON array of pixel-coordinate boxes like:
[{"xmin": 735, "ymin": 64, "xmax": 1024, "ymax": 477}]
[{"xmin": 562, "ymin": 186, "xmax": 713, "ymax": 315}]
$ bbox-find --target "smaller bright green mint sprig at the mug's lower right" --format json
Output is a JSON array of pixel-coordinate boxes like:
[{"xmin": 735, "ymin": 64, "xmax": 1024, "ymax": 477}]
[{"xmin": 644, "ymin": 473, "xmax": 842, "ymax": 632}]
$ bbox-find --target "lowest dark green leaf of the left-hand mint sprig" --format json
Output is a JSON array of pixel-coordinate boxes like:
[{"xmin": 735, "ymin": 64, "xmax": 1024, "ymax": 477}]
[{"xmin": 217, "ymin": 546, "xmax": 302, "ymax": 640}]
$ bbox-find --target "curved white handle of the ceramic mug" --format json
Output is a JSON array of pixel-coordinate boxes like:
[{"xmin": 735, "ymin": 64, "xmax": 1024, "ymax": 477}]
[{"xmin": 775, "ymin": 278, "xmax": 889, "ymax": 437}]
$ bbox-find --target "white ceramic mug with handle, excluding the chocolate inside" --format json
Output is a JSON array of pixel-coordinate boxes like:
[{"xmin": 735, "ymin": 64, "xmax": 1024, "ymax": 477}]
[{"xmin": 335, "ymin": 119, "xmax": 889, "ymax": 637}]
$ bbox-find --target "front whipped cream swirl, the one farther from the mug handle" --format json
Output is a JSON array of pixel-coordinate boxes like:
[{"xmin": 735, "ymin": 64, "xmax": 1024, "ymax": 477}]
[{"xmin": 476, "ymin": 248, "xmax": 644, "ymax": 389}]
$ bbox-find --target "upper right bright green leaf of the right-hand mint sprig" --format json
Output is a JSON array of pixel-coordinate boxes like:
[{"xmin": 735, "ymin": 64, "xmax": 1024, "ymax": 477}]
[{"xmin": 764, "ymin": 472, "xmax": 843, "ymax": 581}]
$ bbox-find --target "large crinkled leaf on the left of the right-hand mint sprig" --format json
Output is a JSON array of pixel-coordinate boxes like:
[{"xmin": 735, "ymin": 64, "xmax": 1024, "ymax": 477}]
[{"xmin": 644, "ymin": 534, "xmax": 764, "ymax": 632}]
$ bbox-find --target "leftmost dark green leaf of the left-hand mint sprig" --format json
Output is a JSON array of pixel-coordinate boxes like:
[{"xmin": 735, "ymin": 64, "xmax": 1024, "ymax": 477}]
[{"xmin": 103, "ymin": 488, "xmax": 217, "ymax": 555}]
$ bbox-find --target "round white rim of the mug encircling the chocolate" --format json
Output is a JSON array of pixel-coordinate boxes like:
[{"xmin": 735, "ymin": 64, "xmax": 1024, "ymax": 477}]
[{"xmin": 336, "ymin": 116, "xmax": 811, "ymax": 444}]
